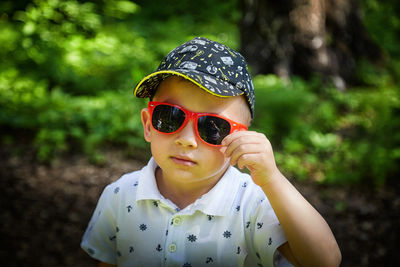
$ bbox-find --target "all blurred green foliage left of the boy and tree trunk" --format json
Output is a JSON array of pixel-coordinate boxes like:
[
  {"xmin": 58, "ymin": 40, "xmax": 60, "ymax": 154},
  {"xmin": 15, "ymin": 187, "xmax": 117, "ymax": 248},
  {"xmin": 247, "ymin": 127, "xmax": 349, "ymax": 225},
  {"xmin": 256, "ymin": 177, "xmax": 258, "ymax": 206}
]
[{"xmin": 0, "ymin": 0, "xmax": 240, "ymax": 163}]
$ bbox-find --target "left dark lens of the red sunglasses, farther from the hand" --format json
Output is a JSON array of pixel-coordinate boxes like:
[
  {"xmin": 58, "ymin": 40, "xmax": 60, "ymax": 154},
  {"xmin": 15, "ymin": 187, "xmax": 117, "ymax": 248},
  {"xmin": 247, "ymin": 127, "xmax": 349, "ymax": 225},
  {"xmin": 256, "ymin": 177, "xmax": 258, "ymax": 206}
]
[{"xmin": 151, "ymin": 105, "xmax": 185, "ymax": 133}]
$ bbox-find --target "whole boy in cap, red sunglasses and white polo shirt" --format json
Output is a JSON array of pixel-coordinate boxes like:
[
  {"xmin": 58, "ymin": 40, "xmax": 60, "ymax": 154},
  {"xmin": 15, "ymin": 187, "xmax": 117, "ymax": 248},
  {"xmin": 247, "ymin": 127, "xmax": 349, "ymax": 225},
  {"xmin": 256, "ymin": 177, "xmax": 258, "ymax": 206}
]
[{"xmin": 81, "ymin": 38, "xmax": 341, "ymax": 266}]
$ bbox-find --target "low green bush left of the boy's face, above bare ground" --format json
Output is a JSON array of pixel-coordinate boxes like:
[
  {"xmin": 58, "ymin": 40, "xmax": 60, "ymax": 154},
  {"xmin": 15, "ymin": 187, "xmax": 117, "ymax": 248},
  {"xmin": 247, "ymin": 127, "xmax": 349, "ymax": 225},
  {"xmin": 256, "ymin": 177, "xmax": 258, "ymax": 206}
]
[{"xmin": 0, "ymin": 74, "xmax": 146, "ymax": 163}]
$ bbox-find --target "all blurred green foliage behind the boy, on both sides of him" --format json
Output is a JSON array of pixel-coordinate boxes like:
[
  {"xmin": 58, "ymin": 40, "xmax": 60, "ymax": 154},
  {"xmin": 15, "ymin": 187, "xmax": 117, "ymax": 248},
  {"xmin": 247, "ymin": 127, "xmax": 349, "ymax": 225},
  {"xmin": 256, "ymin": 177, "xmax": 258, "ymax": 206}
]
[{"xmin": 0, "ymin": 0, "xmax": 400, "ymax": 186}]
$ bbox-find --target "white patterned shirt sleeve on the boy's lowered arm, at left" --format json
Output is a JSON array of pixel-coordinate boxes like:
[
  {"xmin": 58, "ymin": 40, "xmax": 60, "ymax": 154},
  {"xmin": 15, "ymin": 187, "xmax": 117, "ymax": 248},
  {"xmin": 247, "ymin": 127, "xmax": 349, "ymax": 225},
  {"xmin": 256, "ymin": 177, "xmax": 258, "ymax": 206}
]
[{"xmin": 81, "ymin": 184, "xmax": 118, "ymax": 264}]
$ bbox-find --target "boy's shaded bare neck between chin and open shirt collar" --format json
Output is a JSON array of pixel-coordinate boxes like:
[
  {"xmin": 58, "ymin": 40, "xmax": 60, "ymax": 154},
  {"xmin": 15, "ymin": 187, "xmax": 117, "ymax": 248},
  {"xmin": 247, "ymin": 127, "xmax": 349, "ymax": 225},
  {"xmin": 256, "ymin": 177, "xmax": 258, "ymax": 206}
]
[{"xmin": 155, "ymin": 167, "xmax": 226, "ymax": 209}]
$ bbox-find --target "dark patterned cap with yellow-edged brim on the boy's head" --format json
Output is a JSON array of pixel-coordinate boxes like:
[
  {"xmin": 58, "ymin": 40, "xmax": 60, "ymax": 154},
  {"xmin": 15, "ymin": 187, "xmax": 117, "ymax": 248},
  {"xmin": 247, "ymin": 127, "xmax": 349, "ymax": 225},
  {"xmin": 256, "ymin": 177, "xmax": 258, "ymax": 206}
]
[{"xmin": 134, "ymin": 37, "xmax": 255, "ymax": 118}]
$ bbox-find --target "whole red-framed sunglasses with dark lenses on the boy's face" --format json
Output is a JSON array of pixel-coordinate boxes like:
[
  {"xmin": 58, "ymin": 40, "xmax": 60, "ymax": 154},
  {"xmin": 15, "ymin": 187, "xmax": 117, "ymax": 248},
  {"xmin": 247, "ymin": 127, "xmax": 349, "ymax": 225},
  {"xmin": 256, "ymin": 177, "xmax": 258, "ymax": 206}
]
[{"xmin": 148, "ymin": 101, "xmax": 247, "ymax": 146}]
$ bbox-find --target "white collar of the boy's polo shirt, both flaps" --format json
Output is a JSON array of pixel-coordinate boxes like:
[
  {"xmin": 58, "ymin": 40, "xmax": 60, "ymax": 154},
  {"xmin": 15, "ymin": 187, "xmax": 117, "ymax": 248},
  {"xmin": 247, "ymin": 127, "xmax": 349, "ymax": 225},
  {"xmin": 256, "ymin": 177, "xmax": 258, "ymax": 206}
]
[{"xmin": 136, "ymin": 158, "xmax": 240, "ymax": 216}]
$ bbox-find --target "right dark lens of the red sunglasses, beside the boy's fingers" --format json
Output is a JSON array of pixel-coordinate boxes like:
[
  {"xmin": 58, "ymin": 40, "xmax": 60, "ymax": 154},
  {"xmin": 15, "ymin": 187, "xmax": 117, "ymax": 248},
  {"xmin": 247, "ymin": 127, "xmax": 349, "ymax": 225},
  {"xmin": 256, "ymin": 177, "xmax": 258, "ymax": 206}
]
[{"xmin": 197, "ymin": 116, "xmax": 231, "ymax": 145}]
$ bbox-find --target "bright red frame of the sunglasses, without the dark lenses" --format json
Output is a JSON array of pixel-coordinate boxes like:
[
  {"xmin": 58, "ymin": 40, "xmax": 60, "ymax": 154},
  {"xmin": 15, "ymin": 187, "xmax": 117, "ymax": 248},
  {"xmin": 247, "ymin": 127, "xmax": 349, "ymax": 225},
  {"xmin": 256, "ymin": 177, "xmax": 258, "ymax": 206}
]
[{"xmin": 147, "ymin": 101, "xmax": 247, "ymax": 147}]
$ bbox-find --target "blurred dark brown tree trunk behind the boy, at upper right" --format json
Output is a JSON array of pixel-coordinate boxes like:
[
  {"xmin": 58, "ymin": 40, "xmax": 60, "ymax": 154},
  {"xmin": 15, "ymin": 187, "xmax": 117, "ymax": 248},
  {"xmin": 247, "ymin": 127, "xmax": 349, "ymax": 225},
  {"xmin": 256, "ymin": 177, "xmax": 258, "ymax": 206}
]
[{"xmin": 241, "ymin": 0, "xmax": 382, "ymax": 89}]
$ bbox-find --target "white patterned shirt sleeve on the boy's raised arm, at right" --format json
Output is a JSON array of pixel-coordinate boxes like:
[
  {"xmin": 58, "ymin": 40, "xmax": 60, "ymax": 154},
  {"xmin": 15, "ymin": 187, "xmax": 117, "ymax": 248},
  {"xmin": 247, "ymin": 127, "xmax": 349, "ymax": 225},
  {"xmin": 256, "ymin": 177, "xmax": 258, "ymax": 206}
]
[{"xmin": 246, "ymin": 197, "xmax": 286, "ymax": 266}]
